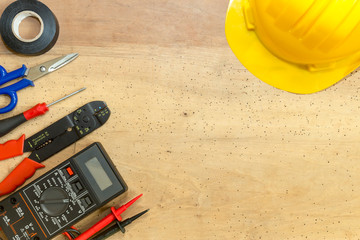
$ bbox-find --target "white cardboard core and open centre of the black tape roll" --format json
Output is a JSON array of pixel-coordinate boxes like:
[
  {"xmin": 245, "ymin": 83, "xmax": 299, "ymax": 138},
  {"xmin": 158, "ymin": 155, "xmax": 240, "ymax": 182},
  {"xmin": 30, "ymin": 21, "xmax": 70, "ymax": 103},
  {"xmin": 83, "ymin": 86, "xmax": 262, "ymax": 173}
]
[{"xmin": 11, "ymin": 11, "xmax": 44, "ymax": 42}]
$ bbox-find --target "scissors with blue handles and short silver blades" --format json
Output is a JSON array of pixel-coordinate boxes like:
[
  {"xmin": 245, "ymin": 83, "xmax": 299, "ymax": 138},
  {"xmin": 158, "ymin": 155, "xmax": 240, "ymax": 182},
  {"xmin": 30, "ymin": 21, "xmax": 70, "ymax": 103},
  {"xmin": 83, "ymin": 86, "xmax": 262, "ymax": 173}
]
[{"xmin": 0, "ymin": 53, "xmax": 78, "ymax": 114}]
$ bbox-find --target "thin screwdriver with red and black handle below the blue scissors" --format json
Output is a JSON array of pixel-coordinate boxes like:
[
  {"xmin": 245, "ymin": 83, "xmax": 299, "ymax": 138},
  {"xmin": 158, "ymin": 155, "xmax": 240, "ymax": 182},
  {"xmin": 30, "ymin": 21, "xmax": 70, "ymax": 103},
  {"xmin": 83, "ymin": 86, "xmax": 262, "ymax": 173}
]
[{"xmin": 0, "ymin": 88, "xmax": 86, "ymax": 137}]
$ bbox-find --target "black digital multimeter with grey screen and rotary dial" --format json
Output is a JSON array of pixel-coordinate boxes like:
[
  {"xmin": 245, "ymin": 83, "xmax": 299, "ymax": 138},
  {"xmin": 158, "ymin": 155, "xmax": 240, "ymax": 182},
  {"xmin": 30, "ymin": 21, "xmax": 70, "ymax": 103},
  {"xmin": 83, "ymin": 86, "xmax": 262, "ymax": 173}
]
[{"xmin": 0, "ymin": 143, "xmax": 127, "ymax": 240}]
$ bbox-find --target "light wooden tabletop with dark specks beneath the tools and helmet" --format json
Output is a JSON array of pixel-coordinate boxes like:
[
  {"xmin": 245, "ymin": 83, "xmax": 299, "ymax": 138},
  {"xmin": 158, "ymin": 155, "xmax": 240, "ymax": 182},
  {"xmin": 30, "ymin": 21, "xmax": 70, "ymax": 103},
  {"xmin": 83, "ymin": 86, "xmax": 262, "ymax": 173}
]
[{"xmin": 0, "ymin": 0, "xmax": 360, "ymax": 240}]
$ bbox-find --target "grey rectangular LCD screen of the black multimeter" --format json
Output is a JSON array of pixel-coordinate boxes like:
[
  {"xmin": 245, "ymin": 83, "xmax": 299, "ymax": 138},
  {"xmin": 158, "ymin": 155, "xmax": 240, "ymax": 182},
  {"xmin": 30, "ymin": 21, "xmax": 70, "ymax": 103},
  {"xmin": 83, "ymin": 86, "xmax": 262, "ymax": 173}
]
[{"xmin": 85, "ymin": 157, "xmax": 112, "ymax": 191}]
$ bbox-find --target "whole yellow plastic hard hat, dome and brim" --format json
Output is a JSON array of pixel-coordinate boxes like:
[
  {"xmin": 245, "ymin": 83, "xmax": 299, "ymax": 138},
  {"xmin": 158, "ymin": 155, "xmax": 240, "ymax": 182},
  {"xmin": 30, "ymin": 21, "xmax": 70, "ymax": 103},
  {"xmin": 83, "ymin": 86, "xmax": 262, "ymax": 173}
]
[{"xmin": 225, "ymin": 0, "xmax": 360, "ymax": 94}]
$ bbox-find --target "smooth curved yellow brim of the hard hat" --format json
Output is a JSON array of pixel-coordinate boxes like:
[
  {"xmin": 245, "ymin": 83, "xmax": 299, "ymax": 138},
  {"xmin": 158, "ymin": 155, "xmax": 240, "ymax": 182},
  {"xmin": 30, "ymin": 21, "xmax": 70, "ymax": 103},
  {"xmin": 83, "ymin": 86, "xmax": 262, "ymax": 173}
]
[{"xmin": 225, "ymin": 0, "xmax": 360, "ymax": 94}]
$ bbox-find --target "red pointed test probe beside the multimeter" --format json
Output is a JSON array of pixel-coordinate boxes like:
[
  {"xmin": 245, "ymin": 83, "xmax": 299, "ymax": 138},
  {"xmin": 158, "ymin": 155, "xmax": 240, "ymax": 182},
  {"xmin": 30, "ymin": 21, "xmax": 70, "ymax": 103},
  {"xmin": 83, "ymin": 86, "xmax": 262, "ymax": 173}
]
[{"xmin": 75, "ymin": 194, "xmax": 142, "ymax": 240}]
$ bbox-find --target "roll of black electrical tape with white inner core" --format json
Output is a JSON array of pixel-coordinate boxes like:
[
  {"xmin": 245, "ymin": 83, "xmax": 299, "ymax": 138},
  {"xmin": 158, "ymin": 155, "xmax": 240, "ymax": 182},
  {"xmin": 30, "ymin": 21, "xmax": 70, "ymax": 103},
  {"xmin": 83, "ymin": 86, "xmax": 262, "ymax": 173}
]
[{"xmin": 0, "ymin": 0, "xmax": 59, "ymax": 55}]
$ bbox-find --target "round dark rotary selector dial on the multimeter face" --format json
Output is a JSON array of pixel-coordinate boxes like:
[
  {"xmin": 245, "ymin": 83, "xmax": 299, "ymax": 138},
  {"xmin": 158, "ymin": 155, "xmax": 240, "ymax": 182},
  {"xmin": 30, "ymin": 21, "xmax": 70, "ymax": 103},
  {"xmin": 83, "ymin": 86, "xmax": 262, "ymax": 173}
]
[{"xmin": 40, "ymin": 187, "xmax": 69, "ymax": 217}]
